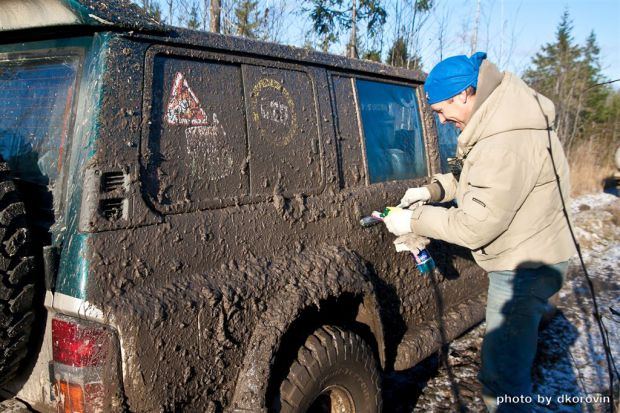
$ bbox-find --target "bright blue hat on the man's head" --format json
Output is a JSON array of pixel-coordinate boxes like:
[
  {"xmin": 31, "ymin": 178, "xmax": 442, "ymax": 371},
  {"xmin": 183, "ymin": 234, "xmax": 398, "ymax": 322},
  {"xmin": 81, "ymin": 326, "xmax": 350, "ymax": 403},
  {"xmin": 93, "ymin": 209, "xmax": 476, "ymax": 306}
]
[{"xmin": 424, "ymin": 52, "xmax": 487, "ymax": 105}]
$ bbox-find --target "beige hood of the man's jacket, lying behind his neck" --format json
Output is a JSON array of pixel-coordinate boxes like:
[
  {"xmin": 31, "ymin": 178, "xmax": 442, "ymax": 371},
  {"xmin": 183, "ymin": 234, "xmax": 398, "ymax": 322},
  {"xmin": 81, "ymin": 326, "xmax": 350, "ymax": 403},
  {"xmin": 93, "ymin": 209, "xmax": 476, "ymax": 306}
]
[{"xmin": 457, "ymin": 63, "xmax": 555, "ymax": 157}]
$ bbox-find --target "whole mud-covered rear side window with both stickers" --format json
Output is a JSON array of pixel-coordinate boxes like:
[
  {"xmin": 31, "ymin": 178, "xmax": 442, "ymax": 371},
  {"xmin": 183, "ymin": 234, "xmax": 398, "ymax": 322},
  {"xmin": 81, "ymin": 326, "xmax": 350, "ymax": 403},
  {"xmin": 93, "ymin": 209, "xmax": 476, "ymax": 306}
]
[{"xmin": 143, "ymin": 52, "xmax": 323, "ymax": 213}]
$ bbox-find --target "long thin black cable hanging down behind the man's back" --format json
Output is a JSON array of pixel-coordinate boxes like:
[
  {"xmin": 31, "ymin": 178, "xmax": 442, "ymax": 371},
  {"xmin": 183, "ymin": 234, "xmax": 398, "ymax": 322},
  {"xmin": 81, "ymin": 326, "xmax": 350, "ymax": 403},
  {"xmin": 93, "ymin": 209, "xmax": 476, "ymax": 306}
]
[{"xmin": 535, "ymin": 94, "xmax": 620, "ymax": 413}]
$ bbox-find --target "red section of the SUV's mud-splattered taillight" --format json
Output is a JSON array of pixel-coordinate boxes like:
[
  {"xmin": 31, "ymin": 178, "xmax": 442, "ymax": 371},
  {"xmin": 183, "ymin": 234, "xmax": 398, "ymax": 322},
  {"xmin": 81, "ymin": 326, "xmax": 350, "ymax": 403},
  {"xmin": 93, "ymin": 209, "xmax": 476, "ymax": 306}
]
[{"xmin": 52, "ymin": 318, "xmax": 109, "ymax": 367}]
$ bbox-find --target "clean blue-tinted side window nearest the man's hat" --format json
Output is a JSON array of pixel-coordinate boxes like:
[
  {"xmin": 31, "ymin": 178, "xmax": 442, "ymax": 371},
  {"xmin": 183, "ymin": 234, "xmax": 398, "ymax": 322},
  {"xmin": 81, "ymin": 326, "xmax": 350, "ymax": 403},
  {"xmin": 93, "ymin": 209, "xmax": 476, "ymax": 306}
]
[{"xmin": 356, "ymin": 79, "xmax": 428, "ymax": 183}]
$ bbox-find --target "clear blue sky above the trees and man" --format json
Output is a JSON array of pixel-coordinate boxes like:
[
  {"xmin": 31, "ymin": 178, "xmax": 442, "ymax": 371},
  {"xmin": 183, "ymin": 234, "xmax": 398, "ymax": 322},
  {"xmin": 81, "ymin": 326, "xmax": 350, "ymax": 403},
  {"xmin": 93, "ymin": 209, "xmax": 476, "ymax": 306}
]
[{"xmin": 283, "ymin": 0, "xmax": 620, "ymax": 82}]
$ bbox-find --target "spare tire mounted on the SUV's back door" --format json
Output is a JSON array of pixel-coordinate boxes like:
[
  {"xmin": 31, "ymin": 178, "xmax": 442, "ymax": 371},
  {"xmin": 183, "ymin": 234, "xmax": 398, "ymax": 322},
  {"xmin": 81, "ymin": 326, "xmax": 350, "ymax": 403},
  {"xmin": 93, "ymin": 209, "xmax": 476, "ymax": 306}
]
[{"xmin": 0, "ymin": 159, "xmax": 37, "ymax": 384}]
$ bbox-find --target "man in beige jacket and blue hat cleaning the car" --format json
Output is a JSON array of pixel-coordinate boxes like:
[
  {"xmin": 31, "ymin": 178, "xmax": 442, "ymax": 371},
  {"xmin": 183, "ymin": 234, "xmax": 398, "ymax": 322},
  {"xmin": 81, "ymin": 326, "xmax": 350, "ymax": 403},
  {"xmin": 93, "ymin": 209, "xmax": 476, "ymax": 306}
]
[{"xmin": 385, "ymin": 52, "xmax": 575, "ymax": 412}]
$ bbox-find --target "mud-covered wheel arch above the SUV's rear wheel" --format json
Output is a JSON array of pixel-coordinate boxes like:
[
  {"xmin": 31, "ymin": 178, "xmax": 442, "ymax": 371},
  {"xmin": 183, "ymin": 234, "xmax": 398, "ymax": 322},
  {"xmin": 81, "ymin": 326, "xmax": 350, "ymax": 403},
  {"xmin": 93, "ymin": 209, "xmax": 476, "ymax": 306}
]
[{"xmin": 229, "ymin": 246, "xmax": 385, "ymax": 413}]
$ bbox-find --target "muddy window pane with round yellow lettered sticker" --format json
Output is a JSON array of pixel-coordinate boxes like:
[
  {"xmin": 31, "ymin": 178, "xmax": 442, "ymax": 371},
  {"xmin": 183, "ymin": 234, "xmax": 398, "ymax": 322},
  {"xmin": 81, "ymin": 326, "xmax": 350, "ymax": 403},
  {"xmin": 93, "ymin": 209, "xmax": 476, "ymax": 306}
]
[{"xmin": 243, "ymin": 65, "xmax": 322, "ymax": 195}]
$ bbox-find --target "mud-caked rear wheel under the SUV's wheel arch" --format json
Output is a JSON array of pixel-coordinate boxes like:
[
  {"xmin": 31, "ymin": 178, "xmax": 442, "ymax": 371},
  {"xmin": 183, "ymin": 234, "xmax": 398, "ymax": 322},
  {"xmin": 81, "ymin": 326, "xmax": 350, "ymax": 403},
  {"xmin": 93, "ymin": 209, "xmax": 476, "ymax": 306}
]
[{"xmin": 280, "ymin": 326, "xmax": 382, "ymax": 413}]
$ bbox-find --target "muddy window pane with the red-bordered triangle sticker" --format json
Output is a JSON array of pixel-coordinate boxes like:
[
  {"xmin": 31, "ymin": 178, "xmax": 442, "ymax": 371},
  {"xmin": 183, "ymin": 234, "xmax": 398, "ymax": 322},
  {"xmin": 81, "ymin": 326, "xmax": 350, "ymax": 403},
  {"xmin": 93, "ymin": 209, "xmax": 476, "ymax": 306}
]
[{"xmin": 145, "ymin": 56, "xmax": 249, "ymax": 211}]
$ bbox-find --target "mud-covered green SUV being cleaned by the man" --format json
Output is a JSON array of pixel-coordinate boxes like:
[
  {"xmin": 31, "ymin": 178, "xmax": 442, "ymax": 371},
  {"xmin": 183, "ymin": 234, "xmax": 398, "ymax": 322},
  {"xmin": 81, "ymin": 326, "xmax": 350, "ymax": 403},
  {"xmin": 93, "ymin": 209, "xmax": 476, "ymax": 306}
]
[{"xmin": 0, "ymin": 0, "xmax": 485, "ymax": 412}]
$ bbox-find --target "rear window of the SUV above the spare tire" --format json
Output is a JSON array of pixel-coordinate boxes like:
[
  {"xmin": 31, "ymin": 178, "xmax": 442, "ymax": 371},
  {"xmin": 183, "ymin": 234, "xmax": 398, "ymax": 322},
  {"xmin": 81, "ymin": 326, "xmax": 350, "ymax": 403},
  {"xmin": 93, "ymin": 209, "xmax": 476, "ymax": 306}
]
[{"xmin": 0, "ymin": 57, "xmax": 78, "ymax": 186}]
